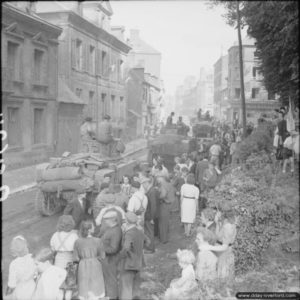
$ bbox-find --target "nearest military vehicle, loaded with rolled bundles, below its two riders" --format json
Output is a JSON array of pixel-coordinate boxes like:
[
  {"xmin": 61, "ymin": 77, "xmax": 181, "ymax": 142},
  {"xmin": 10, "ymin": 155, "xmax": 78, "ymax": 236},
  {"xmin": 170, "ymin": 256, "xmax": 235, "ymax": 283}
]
[{"xmin": 35, "ymin": 147, "xmax": 139, "ymax": 216}]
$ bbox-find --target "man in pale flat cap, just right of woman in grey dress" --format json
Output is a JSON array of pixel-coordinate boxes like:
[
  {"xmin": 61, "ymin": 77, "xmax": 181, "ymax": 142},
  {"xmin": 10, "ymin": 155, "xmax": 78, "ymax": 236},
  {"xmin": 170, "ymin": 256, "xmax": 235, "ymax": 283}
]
[{"xmin": 100, "ymin": 210, "xmax": 122, "ymax": 299}]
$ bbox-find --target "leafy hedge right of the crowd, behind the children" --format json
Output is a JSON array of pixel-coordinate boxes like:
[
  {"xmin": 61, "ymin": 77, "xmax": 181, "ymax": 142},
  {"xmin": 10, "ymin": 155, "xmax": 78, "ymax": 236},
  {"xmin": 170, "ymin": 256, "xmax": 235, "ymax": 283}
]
[{"xmin": 208, "ymin": 152, "xmax": 299, "ymax": 274}]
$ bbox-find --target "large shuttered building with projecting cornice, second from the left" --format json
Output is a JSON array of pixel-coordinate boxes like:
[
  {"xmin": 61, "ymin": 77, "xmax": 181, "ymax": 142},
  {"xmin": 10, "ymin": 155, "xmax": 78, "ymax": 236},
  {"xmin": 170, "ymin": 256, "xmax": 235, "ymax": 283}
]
[{"xmin": 37, "ymin": 1, "xmax": 131, "ymax": 155}]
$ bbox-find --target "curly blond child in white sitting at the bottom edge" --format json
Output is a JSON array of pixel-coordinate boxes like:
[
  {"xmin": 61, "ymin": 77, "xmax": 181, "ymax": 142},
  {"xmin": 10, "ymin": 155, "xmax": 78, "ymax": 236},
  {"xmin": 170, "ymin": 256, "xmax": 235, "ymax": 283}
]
[{"xmin": 164, "ymin": 249, "xmax": 197, "ymax": 300}]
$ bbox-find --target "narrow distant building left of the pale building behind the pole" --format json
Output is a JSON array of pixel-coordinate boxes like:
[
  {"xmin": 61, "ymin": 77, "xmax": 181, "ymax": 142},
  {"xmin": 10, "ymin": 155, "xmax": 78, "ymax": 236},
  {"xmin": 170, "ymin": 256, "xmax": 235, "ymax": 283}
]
[{"xmin": 214, "ymin": 55, "xmax": 228, "ymax": 120}]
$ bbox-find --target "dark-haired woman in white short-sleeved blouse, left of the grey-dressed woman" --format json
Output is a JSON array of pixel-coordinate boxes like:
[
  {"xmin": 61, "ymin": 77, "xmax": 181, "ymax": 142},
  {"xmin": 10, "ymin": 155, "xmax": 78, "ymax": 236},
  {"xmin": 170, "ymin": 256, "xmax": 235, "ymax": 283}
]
[{"xmin": 50, "ymin": 215, "xmax": 78, "ymax": 269}]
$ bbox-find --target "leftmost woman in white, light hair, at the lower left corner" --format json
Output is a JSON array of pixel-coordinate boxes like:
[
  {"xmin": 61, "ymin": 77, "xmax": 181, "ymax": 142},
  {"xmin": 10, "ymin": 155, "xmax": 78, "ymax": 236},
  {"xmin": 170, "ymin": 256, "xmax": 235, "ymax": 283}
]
[{"xmin": 6, "ymin": 235, "xmax": 36, "ymax": 300}]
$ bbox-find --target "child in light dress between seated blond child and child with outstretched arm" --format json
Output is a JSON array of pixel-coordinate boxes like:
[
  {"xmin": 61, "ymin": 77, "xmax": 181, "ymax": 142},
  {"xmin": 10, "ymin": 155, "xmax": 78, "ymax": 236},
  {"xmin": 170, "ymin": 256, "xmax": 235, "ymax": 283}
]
[{"xmin": 196, "ymin": 227, "xmax": 218, "ymax": 282}]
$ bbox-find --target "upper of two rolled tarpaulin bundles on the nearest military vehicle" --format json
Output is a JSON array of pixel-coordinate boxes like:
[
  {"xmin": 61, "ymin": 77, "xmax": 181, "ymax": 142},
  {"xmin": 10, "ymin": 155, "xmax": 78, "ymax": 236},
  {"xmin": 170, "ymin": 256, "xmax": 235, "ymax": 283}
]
[{"xmin": 37, "ymin": 167, "xmax": 82, "ymax": 181}]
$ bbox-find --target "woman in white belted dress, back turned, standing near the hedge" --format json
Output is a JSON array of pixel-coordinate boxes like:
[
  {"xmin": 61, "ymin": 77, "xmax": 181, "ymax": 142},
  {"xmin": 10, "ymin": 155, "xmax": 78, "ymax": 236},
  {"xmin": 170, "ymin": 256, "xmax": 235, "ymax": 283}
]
[{"xmin": 180, "ymin": 174, "xmax": 199, "ymax": 236}]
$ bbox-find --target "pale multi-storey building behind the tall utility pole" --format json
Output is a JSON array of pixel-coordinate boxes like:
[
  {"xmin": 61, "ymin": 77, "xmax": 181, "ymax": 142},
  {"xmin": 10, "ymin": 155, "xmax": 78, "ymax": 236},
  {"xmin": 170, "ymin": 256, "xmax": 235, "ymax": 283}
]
[{"xmin": 227, "ymin": 40, "xmax": 279, "ymax": 124}]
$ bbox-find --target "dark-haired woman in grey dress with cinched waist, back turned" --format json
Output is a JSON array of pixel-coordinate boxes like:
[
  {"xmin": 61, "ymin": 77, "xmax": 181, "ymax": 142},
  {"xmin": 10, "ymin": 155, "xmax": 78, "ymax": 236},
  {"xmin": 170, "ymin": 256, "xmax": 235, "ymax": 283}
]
[{"xmin": 73, "ymin": 220, "xmax": 105, "ymax": 300}]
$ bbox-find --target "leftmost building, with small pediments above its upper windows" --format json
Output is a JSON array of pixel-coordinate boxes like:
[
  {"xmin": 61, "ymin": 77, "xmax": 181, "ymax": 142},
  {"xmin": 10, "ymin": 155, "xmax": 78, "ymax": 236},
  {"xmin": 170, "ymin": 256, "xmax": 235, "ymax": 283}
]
[{"xmin": 1, "ymin": 1, "xmax": 62, "ymax": 168}]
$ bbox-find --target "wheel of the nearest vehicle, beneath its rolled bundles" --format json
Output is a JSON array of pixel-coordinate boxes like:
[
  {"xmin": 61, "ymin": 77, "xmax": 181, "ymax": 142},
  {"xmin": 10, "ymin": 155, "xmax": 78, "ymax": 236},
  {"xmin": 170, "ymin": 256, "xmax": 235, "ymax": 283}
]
[{"xmin": 35, "ymin": 190, "xmax": 62, "ymax": 216}]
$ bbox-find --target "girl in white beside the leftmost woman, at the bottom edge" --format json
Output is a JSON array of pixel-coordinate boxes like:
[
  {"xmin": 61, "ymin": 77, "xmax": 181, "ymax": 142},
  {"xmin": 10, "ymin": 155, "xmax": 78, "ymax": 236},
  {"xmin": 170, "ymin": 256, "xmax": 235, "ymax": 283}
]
[{"xmin": 32, "ymin": 248, "xmax": 67, "ymax": 300}]
